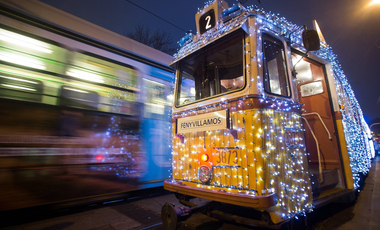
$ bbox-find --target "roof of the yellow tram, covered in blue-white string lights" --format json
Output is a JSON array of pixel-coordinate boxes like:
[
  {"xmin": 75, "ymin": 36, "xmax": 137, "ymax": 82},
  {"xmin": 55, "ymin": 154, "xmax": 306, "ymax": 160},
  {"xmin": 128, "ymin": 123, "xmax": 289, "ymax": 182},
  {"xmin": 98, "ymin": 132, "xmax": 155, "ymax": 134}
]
[{"xmin": 171, "ymin": 0, "xmax": 360, "ymax": 115}]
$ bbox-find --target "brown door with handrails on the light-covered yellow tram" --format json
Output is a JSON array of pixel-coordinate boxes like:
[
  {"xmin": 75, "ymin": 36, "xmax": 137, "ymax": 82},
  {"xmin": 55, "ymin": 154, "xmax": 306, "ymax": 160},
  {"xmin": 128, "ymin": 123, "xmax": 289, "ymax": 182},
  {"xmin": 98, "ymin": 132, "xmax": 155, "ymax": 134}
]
[{"xmin": 292, "ymin": 54, "xmax": 344, "ymax": 191}]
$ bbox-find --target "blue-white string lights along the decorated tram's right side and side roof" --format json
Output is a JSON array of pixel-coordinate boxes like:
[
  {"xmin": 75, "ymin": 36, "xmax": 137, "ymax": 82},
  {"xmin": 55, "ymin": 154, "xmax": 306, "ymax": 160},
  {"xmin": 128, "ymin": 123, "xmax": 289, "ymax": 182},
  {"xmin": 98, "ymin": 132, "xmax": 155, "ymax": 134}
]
[{"xmin": 250, "ymin": 4, "xmax": 372, "ymax": 188}]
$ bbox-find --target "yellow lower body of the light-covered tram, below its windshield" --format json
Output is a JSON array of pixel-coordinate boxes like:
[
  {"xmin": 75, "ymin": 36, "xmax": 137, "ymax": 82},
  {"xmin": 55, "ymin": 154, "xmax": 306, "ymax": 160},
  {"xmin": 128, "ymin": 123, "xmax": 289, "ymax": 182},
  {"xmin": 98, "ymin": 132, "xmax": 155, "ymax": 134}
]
[{"xmin": 165, "ymin": 106, "xmax": 312, "ymax": 223}]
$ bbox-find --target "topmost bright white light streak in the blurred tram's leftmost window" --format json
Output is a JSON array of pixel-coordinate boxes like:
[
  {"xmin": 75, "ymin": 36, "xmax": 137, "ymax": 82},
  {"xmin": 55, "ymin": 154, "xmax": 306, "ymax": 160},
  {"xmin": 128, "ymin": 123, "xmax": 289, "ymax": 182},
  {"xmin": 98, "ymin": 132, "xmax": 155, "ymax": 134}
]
[{"xmin": 0, "ymin": 29, "xmax": 53, "ymax": 53}]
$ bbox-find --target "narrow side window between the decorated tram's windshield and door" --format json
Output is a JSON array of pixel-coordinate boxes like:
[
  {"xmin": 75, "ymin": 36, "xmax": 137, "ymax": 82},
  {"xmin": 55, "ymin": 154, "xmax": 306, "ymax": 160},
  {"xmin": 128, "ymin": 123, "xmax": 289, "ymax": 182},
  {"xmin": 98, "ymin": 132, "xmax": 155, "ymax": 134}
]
[{"xmin": 263, "ymin": 34, "xmax": 290, "ymax": 97}]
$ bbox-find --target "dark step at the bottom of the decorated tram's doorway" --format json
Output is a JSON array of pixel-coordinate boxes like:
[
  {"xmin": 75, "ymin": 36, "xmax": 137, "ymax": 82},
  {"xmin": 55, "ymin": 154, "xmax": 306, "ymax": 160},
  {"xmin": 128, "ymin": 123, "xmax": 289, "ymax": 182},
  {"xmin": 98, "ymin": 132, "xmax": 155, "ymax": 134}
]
[{"xmin": 309, "ymin": 168, "xmax": 339, "ymax": 196}]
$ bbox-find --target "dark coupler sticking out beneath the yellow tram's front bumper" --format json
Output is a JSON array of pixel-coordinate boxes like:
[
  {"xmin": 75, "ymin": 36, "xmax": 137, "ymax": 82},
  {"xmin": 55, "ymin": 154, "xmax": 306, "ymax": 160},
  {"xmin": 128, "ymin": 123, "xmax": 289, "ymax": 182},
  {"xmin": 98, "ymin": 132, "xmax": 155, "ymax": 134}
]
[{"xmin": 161, "ymin": 200, "xmax": 208, "ymax": 230}]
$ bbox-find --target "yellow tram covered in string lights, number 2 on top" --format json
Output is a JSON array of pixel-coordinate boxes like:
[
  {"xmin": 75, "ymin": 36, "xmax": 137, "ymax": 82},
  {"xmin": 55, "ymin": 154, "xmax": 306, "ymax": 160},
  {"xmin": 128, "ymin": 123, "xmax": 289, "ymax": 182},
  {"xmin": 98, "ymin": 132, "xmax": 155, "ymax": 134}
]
[{"xmin": 162, "ymin": 0, "xmax": 374, "ymax": 229}]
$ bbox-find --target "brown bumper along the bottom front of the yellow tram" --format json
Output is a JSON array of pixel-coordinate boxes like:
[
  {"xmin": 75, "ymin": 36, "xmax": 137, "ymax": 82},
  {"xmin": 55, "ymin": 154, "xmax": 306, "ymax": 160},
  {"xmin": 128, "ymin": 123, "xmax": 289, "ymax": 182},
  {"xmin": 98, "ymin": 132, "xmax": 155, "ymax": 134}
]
[{"xmin": 164, "ymin": 180, "xmax": 277, "ymax": 210}]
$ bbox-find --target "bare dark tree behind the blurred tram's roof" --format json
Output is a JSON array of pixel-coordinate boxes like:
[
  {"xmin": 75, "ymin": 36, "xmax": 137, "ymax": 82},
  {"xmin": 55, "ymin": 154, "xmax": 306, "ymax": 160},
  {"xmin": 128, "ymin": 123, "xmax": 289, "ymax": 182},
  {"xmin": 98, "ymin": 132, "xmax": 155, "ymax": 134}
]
[{"xmin": 126, "ymin": 25, "xmax": 176, "ymax": 55}]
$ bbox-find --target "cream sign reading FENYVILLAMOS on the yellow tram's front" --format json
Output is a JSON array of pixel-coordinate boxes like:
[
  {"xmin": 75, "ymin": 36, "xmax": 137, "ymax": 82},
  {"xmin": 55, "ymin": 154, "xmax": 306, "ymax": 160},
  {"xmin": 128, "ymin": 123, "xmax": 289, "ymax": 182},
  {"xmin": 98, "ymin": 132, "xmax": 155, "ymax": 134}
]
[{"xmin": 177, "ymin": 110, "xmax": 229, "ymax": 134}]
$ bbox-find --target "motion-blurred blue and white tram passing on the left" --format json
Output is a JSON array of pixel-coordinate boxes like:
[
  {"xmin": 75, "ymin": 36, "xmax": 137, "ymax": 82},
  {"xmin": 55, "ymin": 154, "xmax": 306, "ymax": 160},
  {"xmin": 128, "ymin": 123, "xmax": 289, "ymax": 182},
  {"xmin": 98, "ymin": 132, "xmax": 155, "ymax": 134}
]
[{"xmin": 0, "ymin": 0, "xmax": 174, "ymax": 211}]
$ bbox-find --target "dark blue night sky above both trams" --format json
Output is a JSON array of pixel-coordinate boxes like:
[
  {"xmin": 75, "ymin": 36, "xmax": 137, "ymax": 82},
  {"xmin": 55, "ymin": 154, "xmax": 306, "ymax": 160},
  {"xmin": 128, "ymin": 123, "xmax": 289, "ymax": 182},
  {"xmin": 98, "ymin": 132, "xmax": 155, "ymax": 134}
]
[{"xmin": 41, "ymin": 0, "xmax": 380, "ymax": 123}]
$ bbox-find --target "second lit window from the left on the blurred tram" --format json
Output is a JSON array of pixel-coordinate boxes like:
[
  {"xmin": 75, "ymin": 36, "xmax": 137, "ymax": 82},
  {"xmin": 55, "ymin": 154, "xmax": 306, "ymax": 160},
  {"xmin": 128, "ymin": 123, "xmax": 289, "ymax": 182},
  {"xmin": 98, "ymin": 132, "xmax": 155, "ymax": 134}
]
[{"xmin": 62, "ymin": 52, "xmax": 140, "ymax": 115}]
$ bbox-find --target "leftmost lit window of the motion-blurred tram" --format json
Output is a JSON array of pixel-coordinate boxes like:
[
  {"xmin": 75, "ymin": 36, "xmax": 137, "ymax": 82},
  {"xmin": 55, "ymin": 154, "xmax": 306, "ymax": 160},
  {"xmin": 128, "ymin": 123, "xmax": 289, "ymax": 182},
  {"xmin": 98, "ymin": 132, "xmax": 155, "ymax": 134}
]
[{"xmin": 0, "ymin": 25, "xmax": 68, "ymax": 105}]
